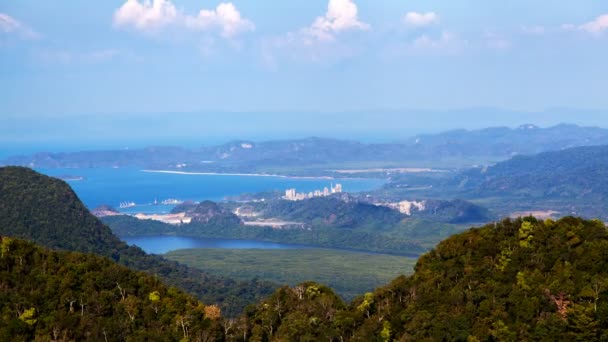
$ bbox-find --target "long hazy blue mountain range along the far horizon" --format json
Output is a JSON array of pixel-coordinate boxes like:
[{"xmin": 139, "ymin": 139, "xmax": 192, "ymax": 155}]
[{"xmin": 0, "ymin": 125, "xmax": 608, "ymax": 172}]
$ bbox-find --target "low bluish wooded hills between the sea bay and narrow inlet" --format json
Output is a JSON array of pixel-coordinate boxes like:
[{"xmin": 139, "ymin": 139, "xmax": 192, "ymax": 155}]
[{"xmin": 108, "ymin": 194, "xmax": 493, "ymax": 255}]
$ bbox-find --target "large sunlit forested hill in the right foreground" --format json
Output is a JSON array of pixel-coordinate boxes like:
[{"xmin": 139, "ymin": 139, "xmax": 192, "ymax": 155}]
[{"xmin": 245, "ymin": 217, "xmax": 608, "ymax": 341}]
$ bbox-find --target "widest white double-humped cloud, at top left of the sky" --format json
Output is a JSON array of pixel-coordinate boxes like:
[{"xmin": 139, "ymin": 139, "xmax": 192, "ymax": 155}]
[{"xmin": 114, "ymin": 0, "xmax": 255, "ymax": 38}]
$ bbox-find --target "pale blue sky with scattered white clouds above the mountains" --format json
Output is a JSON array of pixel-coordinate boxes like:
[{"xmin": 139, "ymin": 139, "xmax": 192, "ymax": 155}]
[{"xmin": 0, "ymin": 0, "xmax": 608, "ymax": 150}]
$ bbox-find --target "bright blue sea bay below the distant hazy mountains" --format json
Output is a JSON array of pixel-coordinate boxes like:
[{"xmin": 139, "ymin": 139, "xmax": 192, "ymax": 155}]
[{"xmin": 37, "ymin": 168, "xmax": 385, "ymax": 213}]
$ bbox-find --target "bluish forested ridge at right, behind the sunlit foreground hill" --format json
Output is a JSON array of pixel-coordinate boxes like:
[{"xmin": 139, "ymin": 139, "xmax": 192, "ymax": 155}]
[{"xmin": 380, "ymin": 146, "xmax": 608, "ymax": 220}]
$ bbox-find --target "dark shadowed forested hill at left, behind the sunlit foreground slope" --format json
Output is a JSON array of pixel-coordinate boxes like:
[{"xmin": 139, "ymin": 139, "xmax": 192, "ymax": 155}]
[{"xmin": 0, "ymin": 167, "xmax": 274, "ymax": 315}]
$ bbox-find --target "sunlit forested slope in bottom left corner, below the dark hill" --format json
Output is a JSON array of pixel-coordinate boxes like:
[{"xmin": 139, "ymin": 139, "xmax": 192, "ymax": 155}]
[{"xmin": 0, "ymin": 237, "xmax": 223, "ymax": 341}]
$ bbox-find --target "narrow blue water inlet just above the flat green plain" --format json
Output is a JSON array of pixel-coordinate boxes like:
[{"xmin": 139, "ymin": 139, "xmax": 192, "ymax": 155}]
[{"xmin": 121, "ymin": 236, "xmax": 318, "ymax": 254}]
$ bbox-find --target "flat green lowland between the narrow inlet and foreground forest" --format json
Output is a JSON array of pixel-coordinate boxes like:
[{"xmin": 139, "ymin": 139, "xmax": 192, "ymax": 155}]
[{"xmin": 165, "ymin": 249, "xmax": 416, "ymax": 300}]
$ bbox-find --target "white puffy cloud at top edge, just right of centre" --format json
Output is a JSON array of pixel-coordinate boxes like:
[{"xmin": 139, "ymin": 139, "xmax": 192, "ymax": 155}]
[{"xmin": 302, "ymin": 0, "xmax": 370, "ymax": 41}]
